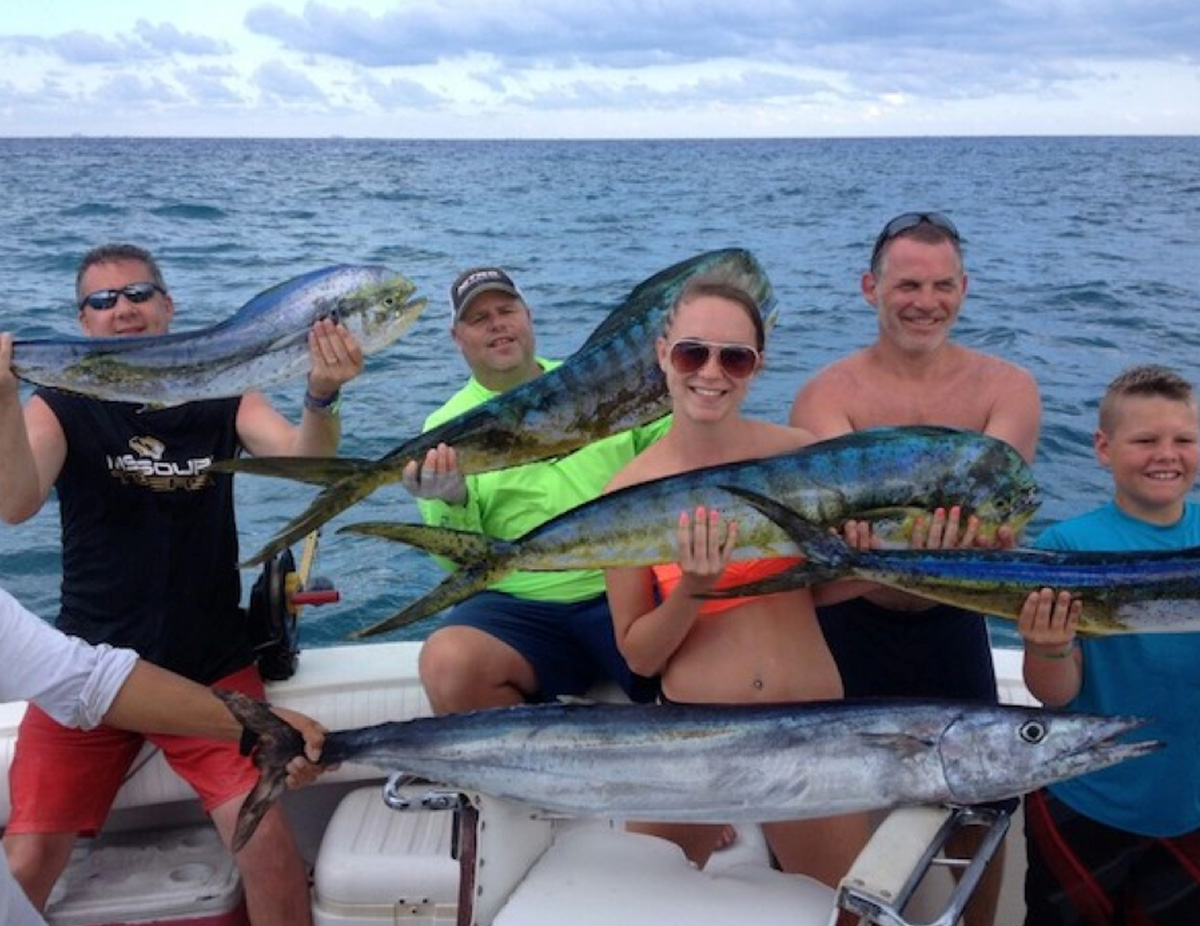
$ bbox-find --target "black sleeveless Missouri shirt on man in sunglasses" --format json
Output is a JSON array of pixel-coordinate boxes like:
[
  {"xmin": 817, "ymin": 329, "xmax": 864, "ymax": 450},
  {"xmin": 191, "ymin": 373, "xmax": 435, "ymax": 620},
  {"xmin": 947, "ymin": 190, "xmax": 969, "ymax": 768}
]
[{"xmin": 37, "ymin": 389, "xmax": 253, "ymax": 684}]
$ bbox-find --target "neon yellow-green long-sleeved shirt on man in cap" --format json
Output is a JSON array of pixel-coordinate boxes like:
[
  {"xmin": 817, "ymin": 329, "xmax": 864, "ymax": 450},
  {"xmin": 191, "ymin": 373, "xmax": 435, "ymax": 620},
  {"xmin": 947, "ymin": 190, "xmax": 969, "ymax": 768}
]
[{"xmin": 418, "ymin": 357, "xmax": 671, "ymax": 603}]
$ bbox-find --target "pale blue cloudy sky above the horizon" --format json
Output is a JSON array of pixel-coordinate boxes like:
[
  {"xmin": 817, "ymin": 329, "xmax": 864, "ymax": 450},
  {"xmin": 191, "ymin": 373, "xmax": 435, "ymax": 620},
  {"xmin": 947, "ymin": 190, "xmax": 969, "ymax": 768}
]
[{"xmin": 0, "ymin": 0, "xmax": 1200, "ymax": 138}]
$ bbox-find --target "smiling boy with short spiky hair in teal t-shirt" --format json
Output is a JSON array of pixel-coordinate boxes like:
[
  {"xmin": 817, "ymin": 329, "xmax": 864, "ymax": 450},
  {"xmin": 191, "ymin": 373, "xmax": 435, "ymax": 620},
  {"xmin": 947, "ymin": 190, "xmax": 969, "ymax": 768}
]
[{"xmin": 1020, "ymin": 366, "xmax": 1200, "ymax": 926}]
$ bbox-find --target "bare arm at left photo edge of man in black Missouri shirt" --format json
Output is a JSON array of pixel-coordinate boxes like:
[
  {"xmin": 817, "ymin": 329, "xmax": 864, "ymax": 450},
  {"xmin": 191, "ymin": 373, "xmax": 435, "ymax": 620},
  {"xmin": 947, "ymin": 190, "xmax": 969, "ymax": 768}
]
[{"xmin": 0, "ymin": 333, "xmax": 67, "ymax": 524}]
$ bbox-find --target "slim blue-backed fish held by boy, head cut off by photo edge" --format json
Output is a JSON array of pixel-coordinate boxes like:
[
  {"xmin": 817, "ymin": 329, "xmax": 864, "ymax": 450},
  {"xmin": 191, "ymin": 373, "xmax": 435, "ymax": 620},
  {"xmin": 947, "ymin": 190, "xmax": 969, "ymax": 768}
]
[{"xmin": 720, "ymin": 486, "xmax": 1200, "ymax": 637}]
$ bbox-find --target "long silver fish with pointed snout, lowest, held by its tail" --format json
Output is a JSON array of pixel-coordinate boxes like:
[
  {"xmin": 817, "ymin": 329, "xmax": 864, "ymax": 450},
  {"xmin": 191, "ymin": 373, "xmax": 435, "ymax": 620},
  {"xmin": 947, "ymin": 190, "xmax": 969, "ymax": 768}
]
[{"xmin": 218, "ymin": 692, "xmax": 1160, "ymax": 848}]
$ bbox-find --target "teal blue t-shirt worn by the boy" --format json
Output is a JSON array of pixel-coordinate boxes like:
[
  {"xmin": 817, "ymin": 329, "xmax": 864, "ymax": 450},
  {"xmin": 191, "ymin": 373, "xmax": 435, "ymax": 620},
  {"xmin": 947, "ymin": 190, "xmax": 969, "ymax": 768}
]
[{"xmin": 1034, "ymin": 503, "xmax": 1200, "ymax": 837}]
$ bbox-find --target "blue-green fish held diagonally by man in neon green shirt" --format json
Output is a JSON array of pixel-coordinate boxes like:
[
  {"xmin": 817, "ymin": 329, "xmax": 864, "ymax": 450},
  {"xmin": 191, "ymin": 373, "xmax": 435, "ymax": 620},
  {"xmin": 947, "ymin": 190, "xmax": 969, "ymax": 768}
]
[{"xmin": 212, "ymin": 248, "xmax": 775, "ymax": 566}]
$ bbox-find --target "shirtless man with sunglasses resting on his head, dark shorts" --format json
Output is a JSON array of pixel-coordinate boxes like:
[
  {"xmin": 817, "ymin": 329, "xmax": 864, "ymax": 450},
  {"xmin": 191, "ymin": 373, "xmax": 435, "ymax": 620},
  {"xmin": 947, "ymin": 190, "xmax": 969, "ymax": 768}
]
[{"xmin": 791, "ymin": 212, "xmax": 1042, "ymax": 926}]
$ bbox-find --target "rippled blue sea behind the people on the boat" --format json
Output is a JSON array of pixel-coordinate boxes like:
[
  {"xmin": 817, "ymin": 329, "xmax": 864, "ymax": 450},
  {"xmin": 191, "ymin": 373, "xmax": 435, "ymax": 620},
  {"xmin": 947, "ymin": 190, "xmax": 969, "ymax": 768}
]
[{"xmin": 0, "ymin": 138, "xmax": 1200, "ymax": 647}]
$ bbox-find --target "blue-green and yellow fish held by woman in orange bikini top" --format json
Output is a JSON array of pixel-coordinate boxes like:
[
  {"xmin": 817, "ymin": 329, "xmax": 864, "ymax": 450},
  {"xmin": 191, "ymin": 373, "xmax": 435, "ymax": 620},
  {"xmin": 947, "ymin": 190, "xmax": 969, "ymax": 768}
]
[{"xmin": 341, "ymin": 427, "xmax": 1038, "ymax": 637}]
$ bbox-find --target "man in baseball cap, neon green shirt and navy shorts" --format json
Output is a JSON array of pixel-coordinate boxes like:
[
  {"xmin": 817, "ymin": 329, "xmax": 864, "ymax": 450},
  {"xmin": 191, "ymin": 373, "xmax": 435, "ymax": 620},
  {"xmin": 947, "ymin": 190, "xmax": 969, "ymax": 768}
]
[{"xmin": 403, "ymin": 266, "xmax": 668, "ymax": 714}]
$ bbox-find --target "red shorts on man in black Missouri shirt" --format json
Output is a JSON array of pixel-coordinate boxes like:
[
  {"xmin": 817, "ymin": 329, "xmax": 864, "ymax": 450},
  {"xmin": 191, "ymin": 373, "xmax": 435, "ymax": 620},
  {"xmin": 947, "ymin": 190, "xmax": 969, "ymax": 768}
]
[{"xmin": 7, "ymin": 666, "xmax": 264, "ymax": 836}]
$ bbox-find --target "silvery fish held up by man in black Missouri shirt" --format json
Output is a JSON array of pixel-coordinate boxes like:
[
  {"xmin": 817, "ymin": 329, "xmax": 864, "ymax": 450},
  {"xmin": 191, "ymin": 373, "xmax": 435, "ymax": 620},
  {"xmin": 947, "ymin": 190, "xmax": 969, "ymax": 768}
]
[{"xmin": 12, "ymin": 265, "xmax": 425, "ymax": 405}]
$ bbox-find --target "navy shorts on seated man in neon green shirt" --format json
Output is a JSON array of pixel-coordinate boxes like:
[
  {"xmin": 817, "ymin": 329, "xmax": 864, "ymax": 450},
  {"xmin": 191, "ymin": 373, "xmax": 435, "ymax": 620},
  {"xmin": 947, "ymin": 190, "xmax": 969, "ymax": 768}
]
[{"xmin": 444, "ymin": 591, "xmax": 659, "ymax": 702}]
